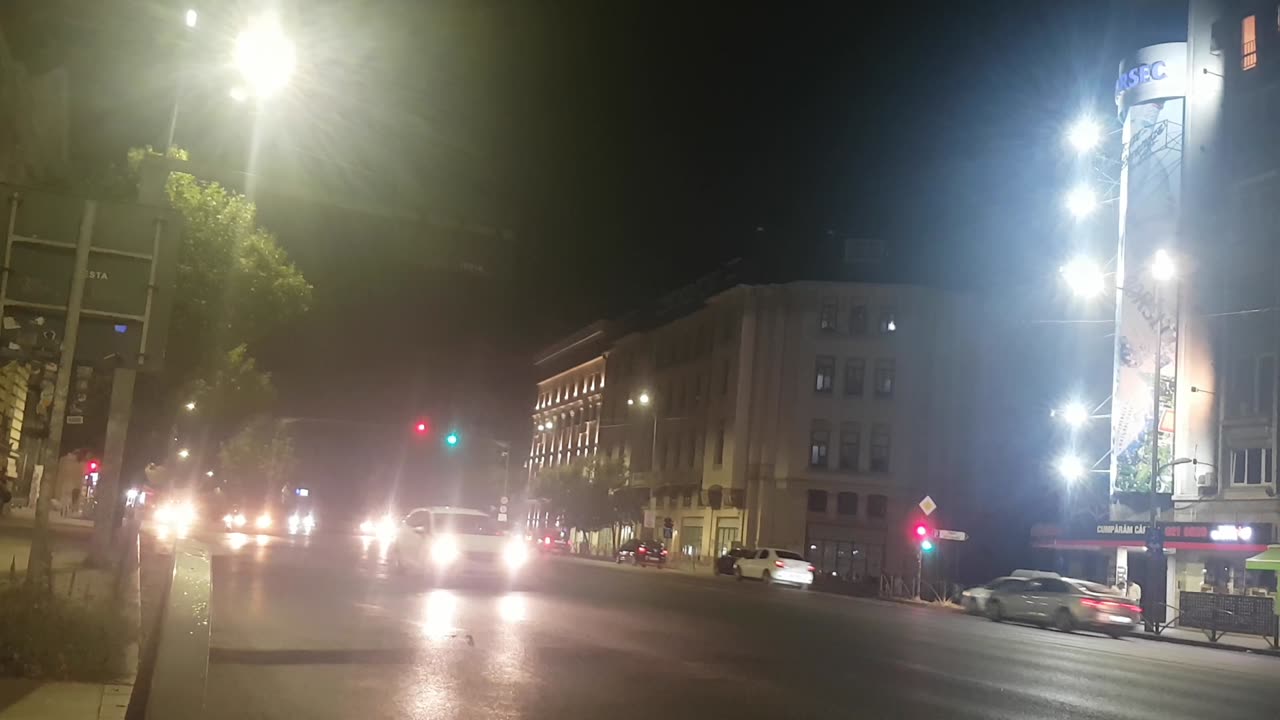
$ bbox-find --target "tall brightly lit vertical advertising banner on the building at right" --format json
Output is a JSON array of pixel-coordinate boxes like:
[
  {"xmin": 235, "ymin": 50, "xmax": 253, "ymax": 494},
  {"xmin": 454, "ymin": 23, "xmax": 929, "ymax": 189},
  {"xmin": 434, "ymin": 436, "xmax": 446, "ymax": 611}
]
[{"xmin": 1111, "ymin": 42, "xmax": 1187, "ymax": 495}]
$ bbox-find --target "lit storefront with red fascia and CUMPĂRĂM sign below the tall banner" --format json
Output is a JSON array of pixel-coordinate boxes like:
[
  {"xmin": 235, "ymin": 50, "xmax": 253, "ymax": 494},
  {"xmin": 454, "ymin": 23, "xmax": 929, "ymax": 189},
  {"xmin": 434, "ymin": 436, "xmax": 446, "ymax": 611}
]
[{"xmin": 1032, "ymin": 523, "xmax": 1276, "ymax": 620}]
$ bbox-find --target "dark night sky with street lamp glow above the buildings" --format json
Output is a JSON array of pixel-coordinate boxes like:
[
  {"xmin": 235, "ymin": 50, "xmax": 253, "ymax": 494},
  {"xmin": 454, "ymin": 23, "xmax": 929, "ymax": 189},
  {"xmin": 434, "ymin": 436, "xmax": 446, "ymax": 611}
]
[{"xmin": 0, "ymin": 0, "xmax": 1185, "ymax": 527}]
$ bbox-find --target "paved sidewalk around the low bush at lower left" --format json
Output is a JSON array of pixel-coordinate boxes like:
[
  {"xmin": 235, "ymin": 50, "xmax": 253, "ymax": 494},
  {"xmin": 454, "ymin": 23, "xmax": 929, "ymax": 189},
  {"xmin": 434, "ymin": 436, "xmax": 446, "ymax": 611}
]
[{"xmin": 0, "ymin": 525, "xmax": 141, "ymax": 720}]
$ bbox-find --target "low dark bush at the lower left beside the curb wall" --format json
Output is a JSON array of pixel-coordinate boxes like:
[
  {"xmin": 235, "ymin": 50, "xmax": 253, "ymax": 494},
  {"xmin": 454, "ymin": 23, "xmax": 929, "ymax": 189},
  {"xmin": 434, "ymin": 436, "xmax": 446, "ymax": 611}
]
[{"xmin": 0, "ymin": 587, "xmax": 131, "ymax": 682}]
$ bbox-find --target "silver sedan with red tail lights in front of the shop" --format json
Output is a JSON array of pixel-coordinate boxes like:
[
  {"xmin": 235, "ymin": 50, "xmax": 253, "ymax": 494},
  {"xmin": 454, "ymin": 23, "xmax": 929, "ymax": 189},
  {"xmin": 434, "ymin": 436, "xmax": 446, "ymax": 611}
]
[{"xmin": 986, "ymin": 577, "xmax": 1142, "ymax": 638}]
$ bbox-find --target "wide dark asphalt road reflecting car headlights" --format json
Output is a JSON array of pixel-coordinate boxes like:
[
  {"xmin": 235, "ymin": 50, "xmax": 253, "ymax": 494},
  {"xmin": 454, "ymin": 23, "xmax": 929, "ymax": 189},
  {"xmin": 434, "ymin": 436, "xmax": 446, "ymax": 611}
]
[{"xmin": 189, "ymin": 536, "xmax": 1280, "ymax": 720}]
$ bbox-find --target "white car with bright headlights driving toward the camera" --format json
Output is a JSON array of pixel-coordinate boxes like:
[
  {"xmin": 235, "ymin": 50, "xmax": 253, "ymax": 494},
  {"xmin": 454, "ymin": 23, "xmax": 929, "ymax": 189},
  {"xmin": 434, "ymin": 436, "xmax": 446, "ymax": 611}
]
[{"xmin": 392, "ymin": 506, "xmax": 529, "ymax": 577}]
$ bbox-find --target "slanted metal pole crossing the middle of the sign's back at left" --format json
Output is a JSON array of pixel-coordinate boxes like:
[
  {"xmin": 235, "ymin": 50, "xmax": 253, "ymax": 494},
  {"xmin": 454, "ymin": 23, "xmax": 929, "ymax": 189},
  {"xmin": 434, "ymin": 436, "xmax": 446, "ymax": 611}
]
[{"xmin": 27, "ymin": 200, "xmax": 97, "ymax": 588}]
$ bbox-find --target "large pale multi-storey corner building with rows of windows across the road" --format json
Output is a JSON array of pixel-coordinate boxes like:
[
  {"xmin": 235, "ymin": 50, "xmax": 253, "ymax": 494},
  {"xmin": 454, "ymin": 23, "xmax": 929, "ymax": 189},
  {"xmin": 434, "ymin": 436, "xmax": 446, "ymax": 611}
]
[{"xmin": 529, "ymin": 266, "xmax": 980, "ymax": 583}]
